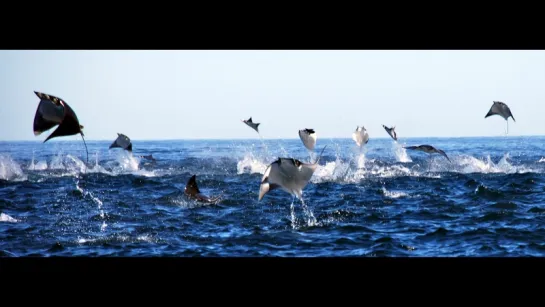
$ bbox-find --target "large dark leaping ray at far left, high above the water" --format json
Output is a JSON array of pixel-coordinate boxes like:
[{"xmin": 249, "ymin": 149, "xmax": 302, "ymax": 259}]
[{"xmin": 33, "ymin": 91, "xmax": 89, "ymax": 164}]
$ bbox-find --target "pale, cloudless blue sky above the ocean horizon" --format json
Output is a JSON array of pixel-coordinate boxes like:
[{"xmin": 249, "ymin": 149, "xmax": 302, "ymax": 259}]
[{"xmin": 0, "ymin": 50, "xmax": 545, "ymax": 141}]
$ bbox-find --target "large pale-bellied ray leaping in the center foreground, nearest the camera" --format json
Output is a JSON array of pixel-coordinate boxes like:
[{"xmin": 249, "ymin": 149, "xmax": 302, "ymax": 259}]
[{"xmin": 258, "ymin": 145, "xmax": 327, "ymax": 201}]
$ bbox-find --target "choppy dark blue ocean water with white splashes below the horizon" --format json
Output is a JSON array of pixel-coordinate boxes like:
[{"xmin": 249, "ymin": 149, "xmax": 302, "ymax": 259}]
[{"xmin": 0, "ymin": 137, "xmax": 545, "ymax": 257}]
